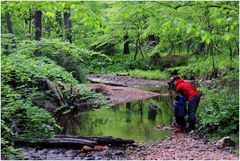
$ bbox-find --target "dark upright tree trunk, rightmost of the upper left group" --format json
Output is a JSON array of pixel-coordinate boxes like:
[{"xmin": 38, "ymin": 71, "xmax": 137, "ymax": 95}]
[{"xmin": 64, "ymin": 9, "xmax": 72, "ymax": 43}]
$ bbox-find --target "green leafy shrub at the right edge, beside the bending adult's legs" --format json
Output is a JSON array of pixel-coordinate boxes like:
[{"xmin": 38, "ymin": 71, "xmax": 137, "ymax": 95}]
[{"xmin": 199, "ymin": 88, "xmax": 239, "ymax": 136}]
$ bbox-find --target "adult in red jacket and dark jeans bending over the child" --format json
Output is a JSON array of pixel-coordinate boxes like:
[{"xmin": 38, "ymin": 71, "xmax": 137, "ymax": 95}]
[{"xmin": 173, "ymin": 76, "xmax": 201, "ymax": 130}]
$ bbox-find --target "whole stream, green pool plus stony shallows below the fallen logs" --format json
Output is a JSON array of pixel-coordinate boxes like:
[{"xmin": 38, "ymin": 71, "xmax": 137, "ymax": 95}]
[{"xmin": 21, "ymin": 87, "xmax": 173, "ymax": 160}]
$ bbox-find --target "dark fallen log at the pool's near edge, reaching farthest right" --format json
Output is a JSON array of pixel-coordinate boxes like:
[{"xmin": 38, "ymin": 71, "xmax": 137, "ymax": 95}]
[{"xmin": 55, "ymin": 135, "xmax": 135, "ymax": 145}]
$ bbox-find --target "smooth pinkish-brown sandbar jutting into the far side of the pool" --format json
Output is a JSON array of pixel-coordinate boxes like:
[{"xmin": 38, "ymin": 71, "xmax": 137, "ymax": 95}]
[{"xmin": 86, "ymin": 84, "xmax": 168, "ymax": 105}]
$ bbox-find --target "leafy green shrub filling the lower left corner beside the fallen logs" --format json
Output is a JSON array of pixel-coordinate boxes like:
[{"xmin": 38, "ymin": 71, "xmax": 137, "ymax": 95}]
[{"xmin": 1, "ymin": 84, "xmax": 58, "ymax": 159}]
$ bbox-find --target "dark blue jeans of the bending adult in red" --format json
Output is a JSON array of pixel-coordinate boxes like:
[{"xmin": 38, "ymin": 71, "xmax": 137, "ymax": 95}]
[{"xmin": 188, "ymin": 94, "xmax": 201, "ymax": 129}]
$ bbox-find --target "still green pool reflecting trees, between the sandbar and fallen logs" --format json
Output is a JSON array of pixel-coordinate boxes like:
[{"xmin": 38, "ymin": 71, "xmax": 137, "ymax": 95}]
[{"xmin": 58, "ymin": 87, "xmax": 172, "ymax": 143}]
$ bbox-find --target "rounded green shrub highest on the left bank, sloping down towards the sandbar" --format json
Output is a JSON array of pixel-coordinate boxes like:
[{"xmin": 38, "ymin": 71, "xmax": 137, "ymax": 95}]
[{"xmin": 18, "ymin": 39, "xmax": 86, "ymax": 82}]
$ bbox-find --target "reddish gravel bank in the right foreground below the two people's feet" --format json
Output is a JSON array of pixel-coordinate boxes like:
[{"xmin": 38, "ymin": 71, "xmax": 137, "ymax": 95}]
[{"xmin": 125, "ymin": 134, "xmax": 239, "ymax": 160}]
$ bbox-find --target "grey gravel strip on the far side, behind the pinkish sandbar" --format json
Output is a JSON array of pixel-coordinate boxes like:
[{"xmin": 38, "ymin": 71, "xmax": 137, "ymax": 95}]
[{"xmin": 87, "ymin": 74, "xmax": 168, "ymax": 88}]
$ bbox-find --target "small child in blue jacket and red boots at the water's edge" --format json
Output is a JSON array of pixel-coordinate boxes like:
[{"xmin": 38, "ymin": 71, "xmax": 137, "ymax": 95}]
[{"xmin": 173, "ymin": 94, "xmax": 187, "ymax": 133}]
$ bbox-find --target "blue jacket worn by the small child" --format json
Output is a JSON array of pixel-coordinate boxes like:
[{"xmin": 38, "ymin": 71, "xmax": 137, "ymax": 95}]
[{"xmin": 173, "ymin": 96, "xmax": 187, "ymax": 117}]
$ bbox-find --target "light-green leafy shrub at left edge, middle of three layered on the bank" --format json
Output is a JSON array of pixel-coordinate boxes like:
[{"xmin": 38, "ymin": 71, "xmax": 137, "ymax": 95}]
[{"xmin": 2, "ymin": 53, "xmax": 78, "ymax": 87}]
